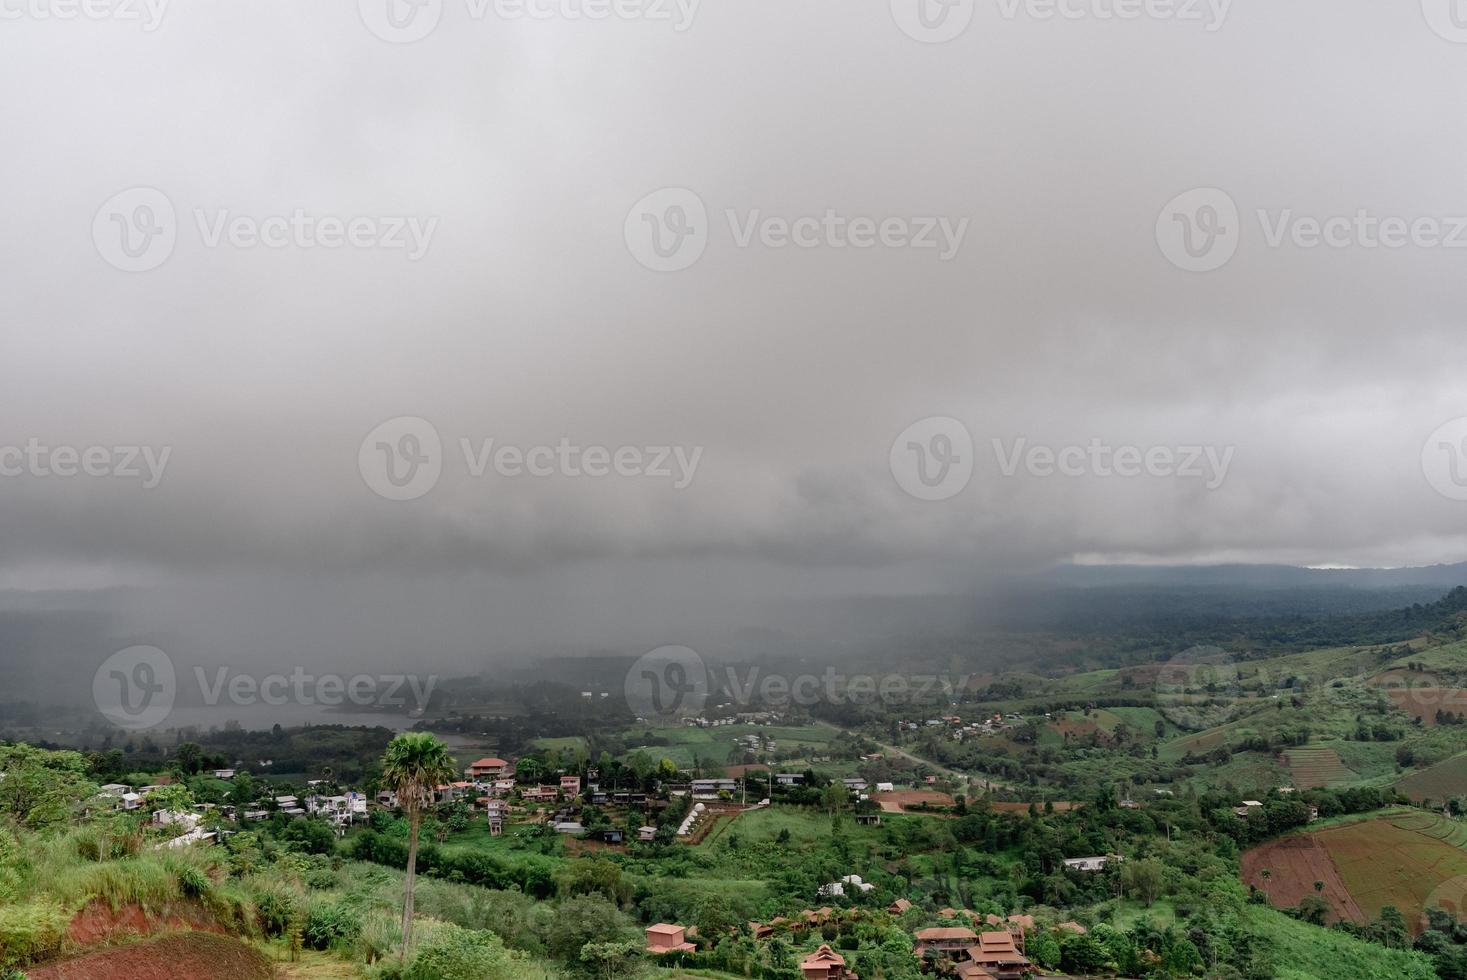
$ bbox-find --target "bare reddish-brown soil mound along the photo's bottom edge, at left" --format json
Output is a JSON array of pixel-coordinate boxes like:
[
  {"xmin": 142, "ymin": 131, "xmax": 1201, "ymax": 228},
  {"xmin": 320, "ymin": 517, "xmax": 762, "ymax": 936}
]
[{"xmin": 26, "ymin": 933, "xmax": 276, "ymax": 980}]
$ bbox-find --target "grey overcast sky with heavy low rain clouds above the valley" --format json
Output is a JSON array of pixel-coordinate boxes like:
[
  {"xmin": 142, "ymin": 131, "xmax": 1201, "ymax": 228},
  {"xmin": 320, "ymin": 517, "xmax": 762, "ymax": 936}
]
[{"xmin": 0, "ymin": 0, "xmax": 1467, "ymax": 674}]
